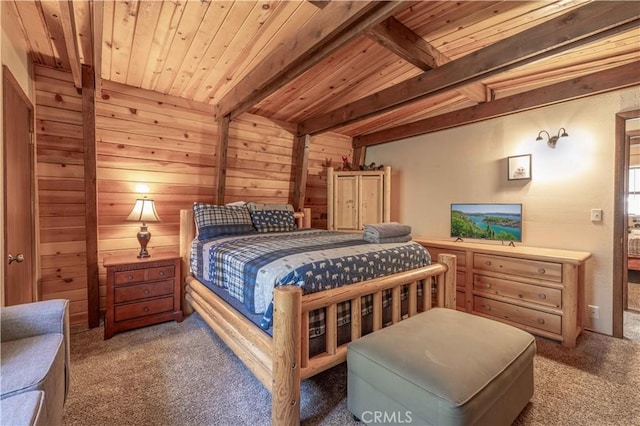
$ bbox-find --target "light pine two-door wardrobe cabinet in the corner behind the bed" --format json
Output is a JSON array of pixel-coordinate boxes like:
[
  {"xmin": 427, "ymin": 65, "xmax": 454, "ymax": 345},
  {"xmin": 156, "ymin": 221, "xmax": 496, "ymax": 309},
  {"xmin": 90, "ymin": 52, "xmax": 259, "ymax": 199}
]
[{"xmin": 327, "ymin": 167, "xmax": 391, "ymax": 231}]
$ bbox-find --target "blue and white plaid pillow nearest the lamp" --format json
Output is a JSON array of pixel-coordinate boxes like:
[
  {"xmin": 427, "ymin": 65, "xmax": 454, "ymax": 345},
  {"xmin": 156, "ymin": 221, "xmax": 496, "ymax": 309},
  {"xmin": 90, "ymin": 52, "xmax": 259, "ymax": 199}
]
[{"xmin": 193, "ymin": 203, "xmax": 255, "ymax": 241}]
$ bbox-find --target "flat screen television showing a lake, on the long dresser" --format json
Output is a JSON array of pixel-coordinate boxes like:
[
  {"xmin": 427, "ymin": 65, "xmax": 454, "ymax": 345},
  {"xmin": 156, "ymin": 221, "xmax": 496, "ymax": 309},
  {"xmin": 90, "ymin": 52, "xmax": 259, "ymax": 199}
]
[{"xmin": 451, "ymin": 204, "xmax": 522, "ymax": 242}]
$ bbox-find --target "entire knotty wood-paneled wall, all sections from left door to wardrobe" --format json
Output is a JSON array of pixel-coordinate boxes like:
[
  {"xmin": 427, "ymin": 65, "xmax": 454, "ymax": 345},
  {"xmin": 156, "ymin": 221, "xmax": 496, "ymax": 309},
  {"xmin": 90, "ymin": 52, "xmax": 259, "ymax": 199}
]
[{"xmin": 36, "ymin": 71, "xmax": 351, "ymax": 324}]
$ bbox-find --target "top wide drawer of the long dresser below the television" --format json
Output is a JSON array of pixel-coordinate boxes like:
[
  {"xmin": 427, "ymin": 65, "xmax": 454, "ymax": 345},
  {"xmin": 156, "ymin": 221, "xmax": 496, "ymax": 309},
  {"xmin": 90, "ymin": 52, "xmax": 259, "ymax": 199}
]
[{"xmin": 473, "ymin": 253, "xmax": 562, "ymax": 282}]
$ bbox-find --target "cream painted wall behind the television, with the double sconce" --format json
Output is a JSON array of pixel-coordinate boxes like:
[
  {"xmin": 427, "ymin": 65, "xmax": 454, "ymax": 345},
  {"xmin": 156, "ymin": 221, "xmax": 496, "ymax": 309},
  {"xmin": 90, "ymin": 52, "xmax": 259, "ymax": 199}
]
[{"xmin": 366, "ymin": 87, "xmax": 640, "ymax": 334}]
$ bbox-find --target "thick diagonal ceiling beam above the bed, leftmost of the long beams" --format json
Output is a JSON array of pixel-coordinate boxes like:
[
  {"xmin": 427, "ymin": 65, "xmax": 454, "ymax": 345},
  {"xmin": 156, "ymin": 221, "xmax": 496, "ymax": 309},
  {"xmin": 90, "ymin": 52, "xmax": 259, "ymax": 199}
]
[{"xmin": 216, "ymin": 1, "xmax": 411, "ymax": 119}]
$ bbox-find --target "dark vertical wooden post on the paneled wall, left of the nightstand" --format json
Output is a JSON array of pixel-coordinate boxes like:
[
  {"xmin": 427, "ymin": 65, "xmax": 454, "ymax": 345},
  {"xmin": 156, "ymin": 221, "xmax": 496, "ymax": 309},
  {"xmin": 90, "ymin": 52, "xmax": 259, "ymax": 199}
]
[{"xmin": 82, "ymin": 65, "xmax": 100, "ymax": 328}]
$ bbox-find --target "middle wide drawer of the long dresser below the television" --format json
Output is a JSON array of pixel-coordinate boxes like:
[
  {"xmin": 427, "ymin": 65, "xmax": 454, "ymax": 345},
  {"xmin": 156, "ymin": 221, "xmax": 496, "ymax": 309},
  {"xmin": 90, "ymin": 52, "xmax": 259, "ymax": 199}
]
[{"xmin": 473, "ymin": 274, "xmax": 562, "ymax": 308}]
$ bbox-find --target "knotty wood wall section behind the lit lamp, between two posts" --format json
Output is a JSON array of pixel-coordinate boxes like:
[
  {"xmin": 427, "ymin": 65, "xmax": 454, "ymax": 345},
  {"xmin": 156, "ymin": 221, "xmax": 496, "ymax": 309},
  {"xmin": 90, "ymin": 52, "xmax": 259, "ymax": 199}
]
[{"xmin": 96, "ymin": 80, "xmax": 217, "ymax": 307}]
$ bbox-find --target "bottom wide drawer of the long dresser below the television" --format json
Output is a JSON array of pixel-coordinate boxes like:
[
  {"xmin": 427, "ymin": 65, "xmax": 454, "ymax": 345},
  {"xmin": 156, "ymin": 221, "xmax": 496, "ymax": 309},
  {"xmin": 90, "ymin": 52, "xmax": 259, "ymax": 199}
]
[{"xmin": 473, "ymin": 296, "xmax": 562, "ymax": 334}]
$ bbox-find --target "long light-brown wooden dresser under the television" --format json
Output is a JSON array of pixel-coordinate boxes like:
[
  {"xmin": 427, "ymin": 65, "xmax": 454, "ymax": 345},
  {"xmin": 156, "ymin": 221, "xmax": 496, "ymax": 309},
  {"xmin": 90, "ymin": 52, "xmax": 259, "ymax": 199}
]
[{"xmin": 414, "ymin": 238, "xmax": 591, "ymax": 347}]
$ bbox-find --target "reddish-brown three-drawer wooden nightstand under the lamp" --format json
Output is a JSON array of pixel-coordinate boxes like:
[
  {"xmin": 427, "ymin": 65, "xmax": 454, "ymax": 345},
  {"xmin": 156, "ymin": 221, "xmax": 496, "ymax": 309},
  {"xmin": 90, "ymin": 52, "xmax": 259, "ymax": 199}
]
[{"xmin": 104, "ymin": 255, "xmax": 182, "ymax": 339}]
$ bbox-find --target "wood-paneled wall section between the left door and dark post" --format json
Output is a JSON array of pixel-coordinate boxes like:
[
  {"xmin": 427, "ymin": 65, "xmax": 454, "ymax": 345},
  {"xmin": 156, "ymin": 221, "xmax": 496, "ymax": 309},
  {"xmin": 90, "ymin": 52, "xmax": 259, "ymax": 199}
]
[{"xmin": 34, "ymin": 65, "xmax": 87, "ymax": 324}]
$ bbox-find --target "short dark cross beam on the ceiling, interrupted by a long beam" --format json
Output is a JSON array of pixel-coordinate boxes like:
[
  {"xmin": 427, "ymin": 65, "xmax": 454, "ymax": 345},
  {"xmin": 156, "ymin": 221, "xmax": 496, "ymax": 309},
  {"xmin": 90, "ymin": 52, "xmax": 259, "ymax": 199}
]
[{"xmin": 366, "ymin": 17, "xmax": 486, "ymax": 102}]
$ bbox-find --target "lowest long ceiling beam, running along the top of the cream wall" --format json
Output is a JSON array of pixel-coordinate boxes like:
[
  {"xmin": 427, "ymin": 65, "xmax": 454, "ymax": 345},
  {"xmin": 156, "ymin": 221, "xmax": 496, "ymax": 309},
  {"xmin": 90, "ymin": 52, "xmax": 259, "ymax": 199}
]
[{"xmin": 353, "ymin": 62, "xmax": 640, "ymax": 148}]
